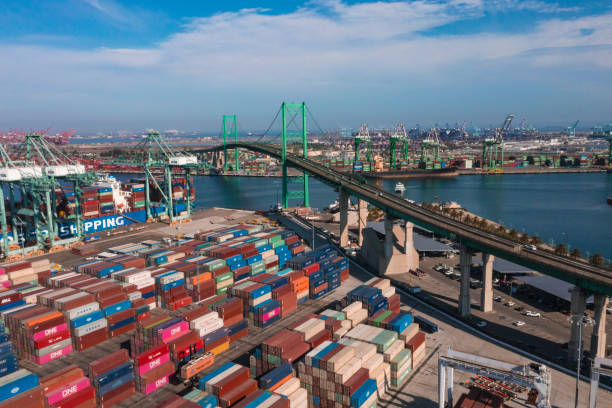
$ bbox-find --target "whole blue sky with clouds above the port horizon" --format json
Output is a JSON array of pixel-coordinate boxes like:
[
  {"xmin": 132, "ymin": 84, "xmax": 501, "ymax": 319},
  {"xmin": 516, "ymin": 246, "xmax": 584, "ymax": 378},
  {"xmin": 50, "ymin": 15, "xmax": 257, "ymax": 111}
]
[{"xmin": 0, "ymin": 0, "xmax": 612, "ymax": 133}]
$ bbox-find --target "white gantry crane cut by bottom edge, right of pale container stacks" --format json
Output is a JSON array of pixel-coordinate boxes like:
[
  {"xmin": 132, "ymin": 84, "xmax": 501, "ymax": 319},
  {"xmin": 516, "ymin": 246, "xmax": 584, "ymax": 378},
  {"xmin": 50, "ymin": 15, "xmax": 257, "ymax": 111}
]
[{"xmin": 438, "ymin": 348, "xmax": 552, "ymax": 408}]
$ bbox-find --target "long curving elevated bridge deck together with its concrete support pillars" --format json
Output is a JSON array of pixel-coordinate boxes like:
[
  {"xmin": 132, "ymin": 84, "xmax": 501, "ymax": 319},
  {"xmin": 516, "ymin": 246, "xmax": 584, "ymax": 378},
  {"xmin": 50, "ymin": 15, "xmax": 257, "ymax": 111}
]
[{"xmin": 192, "ymin": 142, "xmax": 612, "ymax": 359}]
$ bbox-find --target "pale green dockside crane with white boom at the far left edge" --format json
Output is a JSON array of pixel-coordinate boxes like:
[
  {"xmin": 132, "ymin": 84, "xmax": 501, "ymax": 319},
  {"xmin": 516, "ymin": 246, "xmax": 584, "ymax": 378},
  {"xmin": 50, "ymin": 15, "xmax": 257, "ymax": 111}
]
[{"xmin": 0, "ymin": 133, "xmax": 97, "ymax": 257}]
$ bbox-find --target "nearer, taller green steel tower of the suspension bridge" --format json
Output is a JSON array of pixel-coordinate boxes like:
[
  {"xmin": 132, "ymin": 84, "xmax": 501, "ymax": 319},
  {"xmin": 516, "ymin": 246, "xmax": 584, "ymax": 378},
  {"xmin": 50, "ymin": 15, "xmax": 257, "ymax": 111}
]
[{"xmin": 281, "ymin": 102, "xmax": 310, "ymax": 208}]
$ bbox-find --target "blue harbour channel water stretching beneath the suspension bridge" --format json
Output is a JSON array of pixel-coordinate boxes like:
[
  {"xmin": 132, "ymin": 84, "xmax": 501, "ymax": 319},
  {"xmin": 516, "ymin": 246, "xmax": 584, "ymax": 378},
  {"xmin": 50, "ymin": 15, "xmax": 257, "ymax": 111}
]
[{"xmin": 112, "ymin": 173, "xmax": 612, "ymax": 257}]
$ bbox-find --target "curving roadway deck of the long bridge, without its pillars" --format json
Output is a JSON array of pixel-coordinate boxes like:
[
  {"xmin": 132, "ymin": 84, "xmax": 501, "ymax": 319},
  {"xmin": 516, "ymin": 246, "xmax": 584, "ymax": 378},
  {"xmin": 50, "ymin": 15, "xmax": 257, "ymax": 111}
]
[{"xmin": 204, "ymin": 142, "xmax": 612, "ymax": 296}]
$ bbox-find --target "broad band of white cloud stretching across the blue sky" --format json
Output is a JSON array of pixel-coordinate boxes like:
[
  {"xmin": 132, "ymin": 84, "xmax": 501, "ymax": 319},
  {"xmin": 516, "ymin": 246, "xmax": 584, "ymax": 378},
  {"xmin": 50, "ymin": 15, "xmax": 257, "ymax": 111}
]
[{"xmin": 0, "ymin": 0, "xmax": 612, "ymax": 127}]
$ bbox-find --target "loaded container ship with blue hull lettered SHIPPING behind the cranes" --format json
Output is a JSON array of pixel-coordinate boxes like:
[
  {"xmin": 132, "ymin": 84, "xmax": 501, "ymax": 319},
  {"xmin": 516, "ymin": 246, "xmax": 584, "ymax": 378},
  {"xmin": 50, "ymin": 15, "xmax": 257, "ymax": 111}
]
[{"xmin": 2, "ymin": 175, "xmax": 195, "ymax": 246}]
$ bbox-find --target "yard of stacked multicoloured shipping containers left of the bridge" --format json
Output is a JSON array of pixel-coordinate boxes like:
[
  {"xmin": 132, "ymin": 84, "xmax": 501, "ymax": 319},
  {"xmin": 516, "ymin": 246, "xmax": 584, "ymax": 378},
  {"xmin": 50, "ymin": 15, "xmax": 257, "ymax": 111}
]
[{"xmin": 0, "ymin": 210, "xmax": 608, "ymax": 407}]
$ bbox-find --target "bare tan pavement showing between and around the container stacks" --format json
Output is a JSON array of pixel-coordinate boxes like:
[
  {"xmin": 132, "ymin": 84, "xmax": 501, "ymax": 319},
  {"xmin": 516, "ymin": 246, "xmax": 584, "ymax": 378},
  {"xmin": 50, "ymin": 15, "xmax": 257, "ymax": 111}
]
[{"xmin": 15, "ymin": 209, "xmax": 612, "ymax": 407}]
